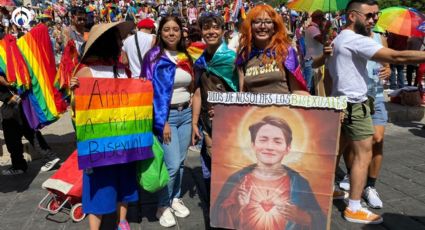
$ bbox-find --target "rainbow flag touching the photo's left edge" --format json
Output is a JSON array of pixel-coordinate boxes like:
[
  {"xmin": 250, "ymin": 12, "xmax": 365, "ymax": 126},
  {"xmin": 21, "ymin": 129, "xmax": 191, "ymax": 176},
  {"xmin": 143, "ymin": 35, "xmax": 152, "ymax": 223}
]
[{"xmin": 0, "ymin": 34, "xmax": 31, "ymax": 94}]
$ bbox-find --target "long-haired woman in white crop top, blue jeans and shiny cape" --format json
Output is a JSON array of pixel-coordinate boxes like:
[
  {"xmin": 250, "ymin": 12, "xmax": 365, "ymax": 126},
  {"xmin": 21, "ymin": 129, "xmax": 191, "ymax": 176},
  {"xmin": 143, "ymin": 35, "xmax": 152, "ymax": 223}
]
[{"xmin": 142, "ymin": 16, "xmax": 193, "ymax": 227}]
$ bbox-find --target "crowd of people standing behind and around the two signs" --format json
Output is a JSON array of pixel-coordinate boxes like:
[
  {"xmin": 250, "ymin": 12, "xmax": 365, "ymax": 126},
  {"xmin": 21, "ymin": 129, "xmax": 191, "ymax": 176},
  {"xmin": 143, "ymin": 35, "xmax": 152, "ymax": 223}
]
[{"xmin": 0, "ymin": 0, "xmax": 425, "ymax": 229}]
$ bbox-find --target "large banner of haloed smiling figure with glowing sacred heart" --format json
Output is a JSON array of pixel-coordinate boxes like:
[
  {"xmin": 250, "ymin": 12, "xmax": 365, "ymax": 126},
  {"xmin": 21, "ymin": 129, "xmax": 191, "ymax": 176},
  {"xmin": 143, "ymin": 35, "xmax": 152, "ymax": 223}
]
[{"xmin": 208, "ymin": 92, "xmax": 347, "ymax": 230}]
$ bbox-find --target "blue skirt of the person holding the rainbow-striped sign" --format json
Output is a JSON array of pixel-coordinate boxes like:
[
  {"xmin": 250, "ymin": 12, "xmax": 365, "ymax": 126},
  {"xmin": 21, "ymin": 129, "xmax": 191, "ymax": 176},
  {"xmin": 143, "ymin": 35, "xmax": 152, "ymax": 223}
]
[{"xmin": 83, "ymin": 162, "xmax": 139, "ymax": 215}]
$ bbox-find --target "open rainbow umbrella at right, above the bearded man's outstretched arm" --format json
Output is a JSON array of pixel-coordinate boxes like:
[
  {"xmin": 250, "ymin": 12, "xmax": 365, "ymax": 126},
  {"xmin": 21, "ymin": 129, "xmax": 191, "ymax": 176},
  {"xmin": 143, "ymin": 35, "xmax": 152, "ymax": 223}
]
[{"xmin": 375, "ymin": 6, "xmax": 425, "ymax": 37}]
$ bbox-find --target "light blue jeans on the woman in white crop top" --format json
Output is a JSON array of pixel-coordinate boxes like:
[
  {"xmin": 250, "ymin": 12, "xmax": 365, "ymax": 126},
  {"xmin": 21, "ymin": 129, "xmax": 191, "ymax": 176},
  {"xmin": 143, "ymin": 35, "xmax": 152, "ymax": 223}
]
[{"xmin": 158, "ymin": 108, "xmax": 192, "ymax": 207}]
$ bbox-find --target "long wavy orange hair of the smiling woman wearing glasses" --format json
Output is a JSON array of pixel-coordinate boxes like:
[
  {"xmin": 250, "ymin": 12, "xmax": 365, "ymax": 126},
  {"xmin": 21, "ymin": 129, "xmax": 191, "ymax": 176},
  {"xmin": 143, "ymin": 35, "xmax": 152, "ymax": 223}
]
[{"xmin": 238, "ymin": 5, "xmax": 291, "ymax": 70}]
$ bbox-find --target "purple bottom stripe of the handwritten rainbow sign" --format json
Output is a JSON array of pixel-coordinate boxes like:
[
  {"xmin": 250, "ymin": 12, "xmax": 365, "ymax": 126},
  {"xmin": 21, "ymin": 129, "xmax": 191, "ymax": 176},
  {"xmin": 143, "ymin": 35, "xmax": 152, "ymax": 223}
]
[{"xmin": 78, "ymin": 146, "xmax": 154, "ymax": 169}]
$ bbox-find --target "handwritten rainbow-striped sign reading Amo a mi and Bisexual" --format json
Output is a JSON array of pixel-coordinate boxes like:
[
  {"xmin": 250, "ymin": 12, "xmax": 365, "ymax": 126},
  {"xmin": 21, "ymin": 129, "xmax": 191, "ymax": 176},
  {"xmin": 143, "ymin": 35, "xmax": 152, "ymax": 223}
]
[{"xmin": 75, "ymin": 78, "xmax": 153, "ymax": 169}]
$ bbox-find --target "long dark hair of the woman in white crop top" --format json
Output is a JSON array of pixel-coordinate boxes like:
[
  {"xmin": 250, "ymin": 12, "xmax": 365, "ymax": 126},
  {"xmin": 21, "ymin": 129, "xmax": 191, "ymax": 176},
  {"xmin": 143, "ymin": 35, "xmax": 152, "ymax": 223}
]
[{"xmin": 154, "ymin": 16, "xmax": 192, "ymax": 65}]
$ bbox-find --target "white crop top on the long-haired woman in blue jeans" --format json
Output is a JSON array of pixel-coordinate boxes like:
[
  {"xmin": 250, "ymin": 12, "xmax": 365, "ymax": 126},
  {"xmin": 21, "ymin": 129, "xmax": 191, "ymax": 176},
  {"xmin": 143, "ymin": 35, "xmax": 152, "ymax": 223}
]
[{"xmin": 165, "ymin": 50, "xmax": 192, "ymax": 105}]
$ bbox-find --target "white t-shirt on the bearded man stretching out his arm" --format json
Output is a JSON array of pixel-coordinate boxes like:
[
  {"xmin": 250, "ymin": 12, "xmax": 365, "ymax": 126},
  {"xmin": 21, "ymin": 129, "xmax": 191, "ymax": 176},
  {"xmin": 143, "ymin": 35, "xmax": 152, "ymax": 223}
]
[{"xmin": 327, "ymin": 29, "xmax": 383, "ymax": 103}]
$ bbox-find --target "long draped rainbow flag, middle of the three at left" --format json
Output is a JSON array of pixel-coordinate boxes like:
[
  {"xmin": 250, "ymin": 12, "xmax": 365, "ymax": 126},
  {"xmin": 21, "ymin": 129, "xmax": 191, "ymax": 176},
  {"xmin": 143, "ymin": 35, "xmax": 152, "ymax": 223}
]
[{"xmin": 17, "ymin": 24, "xmax": 67, "ymax": 129}]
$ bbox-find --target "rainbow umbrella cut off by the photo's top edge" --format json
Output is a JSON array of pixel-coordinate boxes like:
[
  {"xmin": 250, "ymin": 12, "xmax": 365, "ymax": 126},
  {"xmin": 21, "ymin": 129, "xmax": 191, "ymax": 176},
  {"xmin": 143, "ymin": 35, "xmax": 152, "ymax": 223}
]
[{"xmin": 287, "ymin": 0, "xmax": 349, "ymax": 12}]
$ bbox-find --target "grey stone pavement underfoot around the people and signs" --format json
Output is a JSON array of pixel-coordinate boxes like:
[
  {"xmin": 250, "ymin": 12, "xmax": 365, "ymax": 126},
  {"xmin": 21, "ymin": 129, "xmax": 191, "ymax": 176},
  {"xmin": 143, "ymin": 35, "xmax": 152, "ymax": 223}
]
[{"xmin": 0, "ymin": 110, "xmax": 425, "ymax": 230}]
